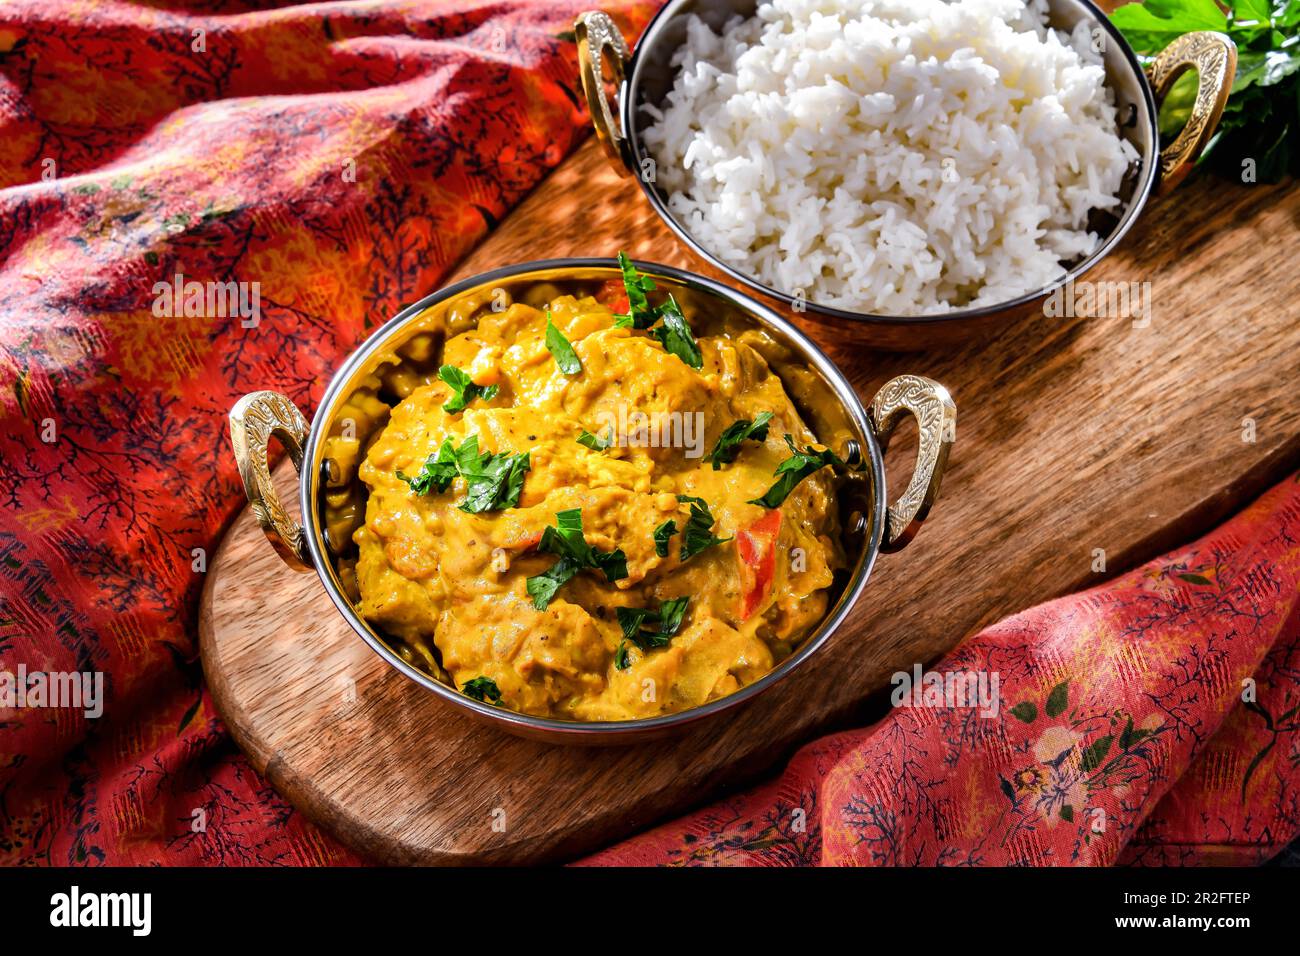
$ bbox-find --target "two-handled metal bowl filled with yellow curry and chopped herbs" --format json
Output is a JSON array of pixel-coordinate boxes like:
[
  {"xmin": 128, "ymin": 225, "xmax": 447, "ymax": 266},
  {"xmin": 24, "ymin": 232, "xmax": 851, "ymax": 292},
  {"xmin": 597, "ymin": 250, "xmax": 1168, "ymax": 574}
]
[{"xmin": 223, "ymin": 260, "xmax": 953, "ymax": 741}]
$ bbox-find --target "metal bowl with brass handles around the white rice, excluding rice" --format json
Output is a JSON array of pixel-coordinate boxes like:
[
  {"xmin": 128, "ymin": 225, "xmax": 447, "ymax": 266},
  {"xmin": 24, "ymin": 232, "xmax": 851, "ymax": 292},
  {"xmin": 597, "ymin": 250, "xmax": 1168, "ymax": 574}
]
[{"xmin": 575, "ymin": 0, "xmax": 1236, "ymax": 350}]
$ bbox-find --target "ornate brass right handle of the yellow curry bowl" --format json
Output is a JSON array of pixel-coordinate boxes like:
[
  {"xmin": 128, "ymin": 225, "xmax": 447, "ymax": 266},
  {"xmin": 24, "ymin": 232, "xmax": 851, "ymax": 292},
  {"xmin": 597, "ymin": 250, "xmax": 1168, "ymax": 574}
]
[{"xmin": 868, "ymin": 375, "xmax": 957, "ymax": 551}]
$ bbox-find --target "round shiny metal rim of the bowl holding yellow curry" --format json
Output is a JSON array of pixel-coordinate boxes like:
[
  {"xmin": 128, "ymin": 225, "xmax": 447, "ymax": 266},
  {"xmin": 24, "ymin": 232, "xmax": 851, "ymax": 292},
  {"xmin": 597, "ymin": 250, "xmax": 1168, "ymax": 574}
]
[{"xmin": 299, "ymin": 259, "xmax": 888, "ymax": 744}]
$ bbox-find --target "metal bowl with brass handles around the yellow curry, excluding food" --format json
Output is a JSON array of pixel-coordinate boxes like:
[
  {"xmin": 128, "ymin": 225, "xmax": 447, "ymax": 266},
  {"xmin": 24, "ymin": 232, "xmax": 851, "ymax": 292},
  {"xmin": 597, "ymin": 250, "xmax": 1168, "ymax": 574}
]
[{"xmin": 230, "ymin": 259, "xmax": 956, "ymax": 744}]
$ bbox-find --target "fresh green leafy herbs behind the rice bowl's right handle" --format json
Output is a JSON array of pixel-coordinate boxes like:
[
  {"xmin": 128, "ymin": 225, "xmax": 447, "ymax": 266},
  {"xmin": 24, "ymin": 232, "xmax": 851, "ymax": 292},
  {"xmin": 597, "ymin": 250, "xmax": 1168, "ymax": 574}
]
[{"xmin": 1110, "ymin": 0, "xmax": 1300, "ymax": 182}]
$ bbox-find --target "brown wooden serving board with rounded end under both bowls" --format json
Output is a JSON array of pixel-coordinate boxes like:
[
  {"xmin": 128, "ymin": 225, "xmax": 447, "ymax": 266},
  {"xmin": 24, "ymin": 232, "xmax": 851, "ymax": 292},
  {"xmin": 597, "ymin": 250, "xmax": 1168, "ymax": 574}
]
[{"xmin": 200, "ymin": 142, "xmax": 1300, "ymax": 864}]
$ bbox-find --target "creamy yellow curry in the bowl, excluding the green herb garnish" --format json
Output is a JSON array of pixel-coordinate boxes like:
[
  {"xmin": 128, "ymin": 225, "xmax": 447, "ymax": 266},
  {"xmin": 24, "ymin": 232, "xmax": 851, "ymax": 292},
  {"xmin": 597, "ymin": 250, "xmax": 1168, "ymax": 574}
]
[{"xmin": 334, "ymin": 280, "xmax": 844, "ymax": 721}]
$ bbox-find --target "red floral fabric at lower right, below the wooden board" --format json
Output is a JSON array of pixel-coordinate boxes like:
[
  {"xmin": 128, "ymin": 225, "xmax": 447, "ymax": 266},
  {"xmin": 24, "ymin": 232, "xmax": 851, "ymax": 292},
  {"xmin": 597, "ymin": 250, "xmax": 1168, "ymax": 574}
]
[{"xmin": 585, "ymin": 479, "xmax": 1300, "ymax": 866}]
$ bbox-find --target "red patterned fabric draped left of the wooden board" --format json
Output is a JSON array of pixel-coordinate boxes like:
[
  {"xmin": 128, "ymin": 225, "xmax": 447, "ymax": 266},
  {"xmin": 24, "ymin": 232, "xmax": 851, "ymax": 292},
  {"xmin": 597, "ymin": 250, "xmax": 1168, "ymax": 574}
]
[{"xmin": 0, "ymin": 0, "xmax": 651, "ymax": 864}]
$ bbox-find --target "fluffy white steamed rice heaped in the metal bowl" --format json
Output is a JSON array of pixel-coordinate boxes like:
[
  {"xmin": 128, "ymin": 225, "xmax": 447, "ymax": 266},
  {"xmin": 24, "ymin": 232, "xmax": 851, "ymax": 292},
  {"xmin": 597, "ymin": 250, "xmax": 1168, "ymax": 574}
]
[{"xmin": 644, "ymin": 0, "xmax": 1138, "ymax": 315}]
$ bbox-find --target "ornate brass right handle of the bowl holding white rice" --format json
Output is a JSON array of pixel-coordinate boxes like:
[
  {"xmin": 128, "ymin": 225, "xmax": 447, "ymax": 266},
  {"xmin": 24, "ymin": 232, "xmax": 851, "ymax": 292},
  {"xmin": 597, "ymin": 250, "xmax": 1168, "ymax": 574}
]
[{"xmin": 1147, "ymin": 30, "xmax": 1236, "ymax": 195}]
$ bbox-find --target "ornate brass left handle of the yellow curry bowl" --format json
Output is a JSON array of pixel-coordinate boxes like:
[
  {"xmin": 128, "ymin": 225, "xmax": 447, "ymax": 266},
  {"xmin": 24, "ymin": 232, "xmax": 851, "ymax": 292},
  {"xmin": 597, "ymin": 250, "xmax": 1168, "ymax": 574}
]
[{"xmin": 230, "ymin": 392, "xmax": 312, "ymax": 571}]
